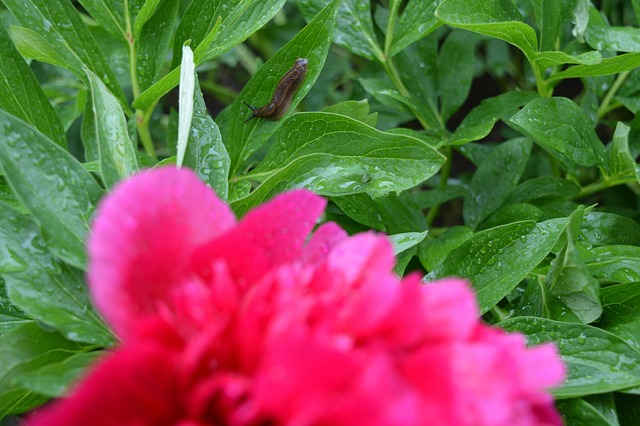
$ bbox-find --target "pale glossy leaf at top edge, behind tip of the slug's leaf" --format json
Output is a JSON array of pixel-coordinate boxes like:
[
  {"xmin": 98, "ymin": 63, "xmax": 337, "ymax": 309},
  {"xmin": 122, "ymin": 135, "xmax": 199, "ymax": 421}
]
[{"xmin": 297, "ymin": 0, "xmax": 384, "ymax": 62}]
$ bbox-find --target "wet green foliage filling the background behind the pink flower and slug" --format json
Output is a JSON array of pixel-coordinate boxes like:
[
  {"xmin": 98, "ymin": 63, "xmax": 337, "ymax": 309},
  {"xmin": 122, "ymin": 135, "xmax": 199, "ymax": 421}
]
[{"xmin": 0, "ymin": 0, "xmax": 640, "ymax": 425}]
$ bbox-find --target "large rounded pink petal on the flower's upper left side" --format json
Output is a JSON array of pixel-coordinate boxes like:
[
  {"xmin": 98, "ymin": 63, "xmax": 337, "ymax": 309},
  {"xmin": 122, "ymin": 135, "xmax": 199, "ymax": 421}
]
[{"xmin": 88, "ymin": 167, "xmax": 235, "ymax": 338}]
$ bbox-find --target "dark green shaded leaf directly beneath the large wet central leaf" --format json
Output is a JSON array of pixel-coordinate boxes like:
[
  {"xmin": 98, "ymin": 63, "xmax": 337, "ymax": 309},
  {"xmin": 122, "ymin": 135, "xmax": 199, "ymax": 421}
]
[{"xmin": 332, "ymin": 192, "xmax": 427, "ymax": 234}]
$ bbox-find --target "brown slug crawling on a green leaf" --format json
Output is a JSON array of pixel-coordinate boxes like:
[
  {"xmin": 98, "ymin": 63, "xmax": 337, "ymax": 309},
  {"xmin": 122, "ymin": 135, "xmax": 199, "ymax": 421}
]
[{"xmin": 242, "ymin": 58, "xmax": 309, "ymax": 123}]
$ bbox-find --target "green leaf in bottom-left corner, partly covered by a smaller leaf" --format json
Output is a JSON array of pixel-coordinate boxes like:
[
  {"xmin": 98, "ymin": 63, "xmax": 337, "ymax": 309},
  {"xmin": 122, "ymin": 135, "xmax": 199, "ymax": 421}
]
[{"xmin": 0, "ymin": 323, "xmax": 87, "ymax": 418}]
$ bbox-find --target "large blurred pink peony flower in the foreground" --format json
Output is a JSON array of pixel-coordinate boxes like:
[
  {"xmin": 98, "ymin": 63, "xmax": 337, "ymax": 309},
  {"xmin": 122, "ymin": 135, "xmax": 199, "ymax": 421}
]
[{"xmin": 30, "ymin": 168, "xmax": 564, "ymax": 426}]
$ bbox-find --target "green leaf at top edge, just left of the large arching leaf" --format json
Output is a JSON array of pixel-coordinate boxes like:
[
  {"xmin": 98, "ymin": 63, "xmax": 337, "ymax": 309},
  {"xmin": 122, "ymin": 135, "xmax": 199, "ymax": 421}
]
[{"xmin": 391, "ymin": 0, "xmax": 442, "ymax": 56}]
